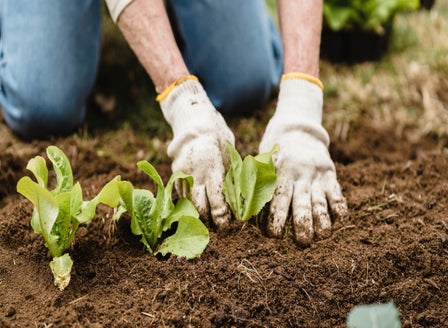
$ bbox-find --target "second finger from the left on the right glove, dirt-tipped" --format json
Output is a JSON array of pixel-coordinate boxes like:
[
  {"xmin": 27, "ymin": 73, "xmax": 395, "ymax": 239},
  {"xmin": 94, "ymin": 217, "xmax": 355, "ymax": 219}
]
[{"xmin": 292, "ymin": 179, "xmax": 314, "ymax": 246}]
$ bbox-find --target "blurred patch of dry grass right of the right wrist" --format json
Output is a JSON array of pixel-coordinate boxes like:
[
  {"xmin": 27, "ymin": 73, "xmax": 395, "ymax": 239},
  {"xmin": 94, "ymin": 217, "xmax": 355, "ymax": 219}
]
[{"xmin": 321, "ymin": 1, "xmax": 448, "ymax": 141}]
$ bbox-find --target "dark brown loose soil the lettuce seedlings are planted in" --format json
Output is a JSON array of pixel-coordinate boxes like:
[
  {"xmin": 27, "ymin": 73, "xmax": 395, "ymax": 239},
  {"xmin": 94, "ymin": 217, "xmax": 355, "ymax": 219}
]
[{"xmin": 0, "ymin": 111, "xmax": 448, "ymax": 327}]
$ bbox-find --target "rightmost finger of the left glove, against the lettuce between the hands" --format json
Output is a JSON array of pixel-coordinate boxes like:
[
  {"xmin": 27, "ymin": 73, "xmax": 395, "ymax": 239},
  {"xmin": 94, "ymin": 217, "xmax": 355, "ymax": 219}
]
[{"xmin": 205, "ymin": 175, "xmax": 230, "ymax": 229}]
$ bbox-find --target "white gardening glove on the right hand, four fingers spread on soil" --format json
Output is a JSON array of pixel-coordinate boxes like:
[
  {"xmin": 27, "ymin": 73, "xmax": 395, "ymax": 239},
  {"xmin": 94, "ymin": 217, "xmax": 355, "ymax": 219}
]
[{"xmin": 259, "ymin": 73, "xmax": 347, "ymax": 246}]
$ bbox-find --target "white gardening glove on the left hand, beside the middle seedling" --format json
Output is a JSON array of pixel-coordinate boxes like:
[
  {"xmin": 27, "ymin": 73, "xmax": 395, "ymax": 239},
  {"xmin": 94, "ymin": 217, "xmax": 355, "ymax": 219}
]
[{"xmin": 157, "ymin": 76, "xmax": 235, "ymax": 228}]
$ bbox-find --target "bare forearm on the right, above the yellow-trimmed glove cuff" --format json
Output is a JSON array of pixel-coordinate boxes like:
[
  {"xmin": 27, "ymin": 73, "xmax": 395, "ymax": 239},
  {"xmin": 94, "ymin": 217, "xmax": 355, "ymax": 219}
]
[{"xmin": 277, "ymin": 0, "xmax": 322, "ymax": 78}]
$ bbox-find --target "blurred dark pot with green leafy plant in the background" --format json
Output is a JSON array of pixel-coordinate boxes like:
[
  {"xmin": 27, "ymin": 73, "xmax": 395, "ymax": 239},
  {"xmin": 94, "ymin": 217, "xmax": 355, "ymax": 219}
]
[{"xmin": 321, "ymin": 0, "xmax": 420, "ymax": 63}]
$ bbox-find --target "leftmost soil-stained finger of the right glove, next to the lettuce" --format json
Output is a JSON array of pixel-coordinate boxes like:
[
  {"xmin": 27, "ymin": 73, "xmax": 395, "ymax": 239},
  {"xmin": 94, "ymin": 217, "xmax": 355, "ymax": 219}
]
[{"xmin": 267, "ymin": 175, "xmax": 293, "ymax": 238}]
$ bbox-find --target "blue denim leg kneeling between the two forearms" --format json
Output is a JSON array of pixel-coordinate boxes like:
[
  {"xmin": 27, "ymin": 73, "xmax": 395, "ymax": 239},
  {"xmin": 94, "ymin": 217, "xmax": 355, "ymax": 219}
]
[{"xmin": 168, "ymin": 0, "xmax": 283, "ymax": 114}]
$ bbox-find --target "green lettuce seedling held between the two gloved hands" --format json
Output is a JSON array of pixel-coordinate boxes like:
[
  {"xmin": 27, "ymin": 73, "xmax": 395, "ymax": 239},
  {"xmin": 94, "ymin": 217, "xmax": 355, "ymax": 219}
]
[{"xmin": 223, "ymin": 142, "xmax": 278, "ymax": 221}]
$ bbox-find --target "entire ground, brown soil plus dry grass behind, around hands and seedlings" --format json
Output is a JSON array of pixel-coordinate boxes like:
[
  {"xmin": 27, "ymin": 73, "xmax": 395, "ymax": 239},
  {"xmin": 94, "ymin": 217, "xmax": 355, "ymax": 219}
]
[{"xmin": 0, "ymin": 2, "xmax": 448, "ymax": 328}]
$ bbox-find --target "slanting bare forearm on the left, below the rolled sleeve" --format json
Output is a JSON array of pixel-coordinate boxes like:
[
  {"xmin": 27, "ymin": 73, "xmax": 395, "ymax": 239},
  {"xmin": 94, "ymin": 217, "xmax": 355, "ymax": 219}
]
[{"xmin": 117, "ymin": 0, "xmax": 189, "ymax": 93}]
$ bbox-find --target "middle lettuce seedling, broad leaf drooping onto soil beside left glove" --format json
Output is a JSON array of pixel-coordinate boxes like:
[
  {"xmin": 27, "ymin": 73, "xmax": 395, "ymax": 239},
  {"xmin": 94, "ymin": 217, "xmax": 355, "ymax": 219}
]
[{"xmin": 115, "ymin": 161, "xmax": 209, "ymax": 259}]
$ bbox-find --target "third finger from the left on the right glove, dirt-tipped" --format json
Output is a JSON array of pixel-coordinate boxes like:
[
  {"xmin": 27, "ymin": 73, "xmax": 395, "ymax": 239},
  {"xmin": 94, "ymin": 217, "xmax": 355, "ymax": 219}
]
[{"xmin": 311, "ymin": 181, "xmax": 331, "ymax": 239}]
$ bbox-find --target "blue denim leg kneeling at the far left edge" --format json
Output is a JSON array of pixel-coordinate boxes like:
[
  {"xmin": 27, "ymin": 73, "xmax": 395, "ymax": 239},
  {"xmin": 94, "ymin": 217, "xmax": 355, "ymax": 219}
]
[{"xmin": 0, "ymin": 0, "xmax": 101, "ymax": 138}]
